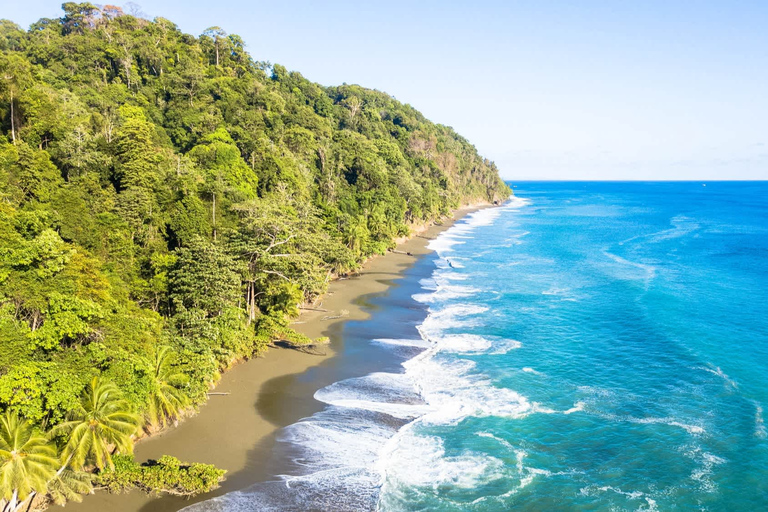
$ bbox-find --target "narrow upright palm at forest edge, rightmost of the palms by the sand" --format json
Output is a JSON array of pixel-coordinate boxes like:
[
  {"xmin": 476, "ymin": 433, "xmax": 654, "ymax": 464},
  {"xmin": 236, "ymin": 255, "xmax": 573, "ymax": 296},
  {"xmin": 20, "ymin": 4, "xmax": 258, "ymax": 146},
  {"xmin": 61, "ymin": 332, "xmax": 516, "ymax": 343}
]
[{"xmin": 146, "ymin": 346, "xmax": 189, "ymax": 428}]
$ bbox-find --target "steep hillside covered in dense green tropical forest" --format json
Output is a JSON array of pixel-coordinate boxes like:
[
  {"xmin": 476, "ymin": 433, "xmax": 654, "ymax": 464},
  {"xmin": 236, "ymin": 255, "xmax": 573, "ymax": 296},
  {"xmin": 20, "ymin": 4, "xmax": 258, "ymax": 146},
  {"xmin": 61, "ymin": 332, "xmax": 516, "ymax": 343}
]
[{"xmin": 0, "ymin": 3, "xmax": 510, "ymax": 508}]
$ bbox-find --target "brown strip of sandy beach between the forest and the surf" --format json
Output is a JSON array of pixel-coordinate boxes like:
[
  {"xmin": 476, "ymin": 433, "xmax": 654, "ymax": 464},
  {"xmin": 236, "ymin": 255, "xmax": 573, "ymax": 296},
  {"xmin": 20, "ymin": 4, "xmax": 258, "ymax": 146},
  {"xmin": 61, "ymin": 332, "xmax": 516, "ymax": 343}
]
[{"xmin": 67, "ymin": 207, "xmax": 486, "ymax": 512}]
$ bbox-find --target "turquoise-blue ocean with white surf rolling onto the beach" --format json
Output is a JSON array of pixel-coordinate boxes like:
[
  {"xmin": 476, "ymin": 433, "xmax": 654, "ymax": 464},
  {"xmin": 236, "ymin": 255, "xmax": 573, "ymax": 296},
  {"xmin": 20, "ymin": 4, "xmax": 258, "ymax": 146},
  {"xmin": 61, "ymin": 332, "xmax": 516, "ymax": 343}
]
[{"xmin": 190, "ymin": 182, "xmax": 768, "ymax": 512}]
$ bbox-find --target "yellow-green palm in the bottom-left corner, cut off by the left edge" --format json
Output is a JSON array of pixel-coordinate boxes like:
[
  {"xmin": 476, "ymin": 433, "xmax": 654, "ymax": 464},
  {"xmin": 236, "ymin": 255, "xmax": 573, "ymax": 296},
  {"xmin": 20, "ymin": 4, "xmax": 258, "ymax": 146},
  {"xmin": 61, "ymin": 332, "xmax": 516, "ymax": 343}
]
[{"xmin": 0, "ymin": 411, "xmax": 58, "ymax": 512}]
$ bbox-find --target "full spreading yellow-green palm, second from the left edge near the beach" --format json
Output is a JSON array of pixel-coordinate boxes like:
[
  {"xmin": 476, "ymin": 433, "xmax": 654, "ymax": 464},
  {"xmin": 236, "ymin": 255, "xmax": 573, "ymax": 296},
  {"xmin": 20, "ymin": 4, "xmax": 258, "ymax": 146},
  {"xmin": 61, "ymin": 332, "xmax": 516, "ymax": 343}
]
[{"xmin": 52, "ymin": 377, "xmax": 139, "ymax": 469}]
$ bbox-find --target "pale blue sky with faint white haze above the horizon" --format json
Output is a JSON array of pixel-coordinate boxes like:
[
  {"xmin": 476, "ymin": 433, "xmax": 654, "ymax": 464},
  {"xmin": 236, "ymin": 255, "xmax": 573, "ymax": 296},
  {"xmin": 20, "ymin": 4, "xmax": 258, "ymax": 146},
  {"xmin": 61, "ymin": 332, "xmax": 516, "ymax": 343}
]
[{"xmin": 0, "ymin": 0, "xmax": 768, "ymax": 180}]
